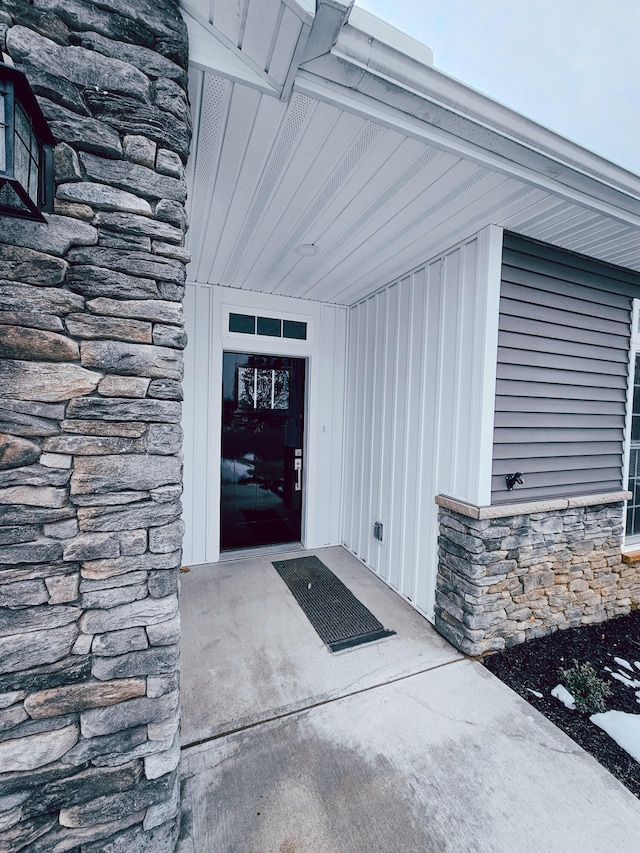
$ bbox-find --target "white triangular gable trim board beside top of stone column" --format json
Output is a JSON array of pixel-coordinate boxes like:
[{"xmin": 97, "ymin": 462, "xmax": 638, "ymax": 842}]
[{"xmin": 181, "ymin": 8, "xmax": 280, "ymax": 97}]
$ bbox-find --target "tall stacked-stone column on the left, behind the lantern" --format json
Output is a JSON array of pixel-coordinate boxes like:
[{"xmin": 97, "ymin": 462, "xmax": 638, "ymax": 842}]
[{"xmin": 0, "ymin": 0, "xmax": 190, "ymax": 853}]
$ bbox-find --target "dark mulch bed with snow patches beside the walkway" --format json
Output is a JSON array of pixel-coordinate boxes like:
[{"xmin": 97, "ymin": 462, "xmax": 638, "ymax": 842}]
[{"xmin": 484, "ymin": 610, "xmax": 640, "ymax": 798}]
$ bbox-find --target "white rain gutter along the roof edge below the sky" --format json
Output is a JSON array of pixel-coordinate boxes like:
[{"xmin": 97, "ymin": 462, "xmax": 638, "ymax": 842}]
[{"xmin": 303, "ymin": 34, "xmax": 640, "ymax": 220}]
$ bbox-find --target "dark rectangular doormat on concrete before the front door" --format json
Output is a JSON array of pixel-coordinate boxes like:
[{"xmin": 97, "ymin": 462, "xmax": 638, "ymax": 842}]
[{"xmin": 273, "ymin": 557, "xmax": 395, "ymax": 652}]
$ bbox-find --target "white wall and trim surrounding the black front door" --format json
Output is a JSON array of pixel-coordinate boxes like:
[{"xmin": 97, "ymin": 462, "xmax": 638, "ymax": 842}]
[{"xmin": 183, "ymin": 284, "xmax": 347, "ymax": 565}]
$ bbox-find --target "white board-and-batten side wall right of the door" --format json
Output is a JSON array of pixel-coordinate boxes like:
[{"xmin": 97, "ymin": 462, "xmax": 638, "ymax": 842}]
[{"xmin": 343, "ymin": 226, "xmax": 502, "ymax": 617}]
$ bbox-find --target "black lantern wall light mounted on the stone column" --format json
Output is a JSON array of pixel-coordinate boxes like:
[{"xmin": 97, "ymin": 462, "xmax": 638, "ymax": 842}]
[{"xmin": 0, "ymin": 54, "xmax": 55, "ymax": 222}]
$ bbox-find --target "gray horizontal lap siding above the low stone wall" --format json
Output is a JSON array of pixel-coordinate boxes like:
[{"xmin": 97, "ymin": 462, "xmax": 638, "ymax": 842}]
[{"xmin": 492, "ymin": 234, "xmax": 640, "ymax": 504}]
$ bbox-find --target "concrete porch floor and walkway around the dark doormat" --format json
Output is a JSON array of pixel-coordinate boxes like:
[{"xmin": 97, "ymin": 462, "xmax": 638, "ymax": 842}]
[{"xmin": 180, "ymin": 548, "xmax": 640, "ymax": 853}]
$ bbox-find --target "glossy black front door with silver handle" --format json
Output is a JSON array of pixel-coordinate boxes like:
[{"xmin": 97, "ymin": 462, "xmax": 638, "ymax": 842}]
[{"xmin": 220, "ymin": 352, "xmax": 304, "ymax": 549}]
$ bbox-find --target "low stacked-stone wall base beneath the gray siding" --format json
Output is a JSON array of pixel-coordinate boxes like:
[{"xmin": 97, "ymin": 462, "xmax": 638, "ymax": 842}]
[{"xmin": 435, "ymin": 501, "xmax": 640, "ymax": 655}]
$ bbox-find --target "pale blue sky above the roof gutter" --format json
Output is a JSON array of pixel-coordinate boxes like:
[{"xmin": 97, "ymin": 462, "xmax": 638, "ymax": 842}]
[{"xmin": 356, "ymin": 0, "xmax": 640, "ymax": 174}]
